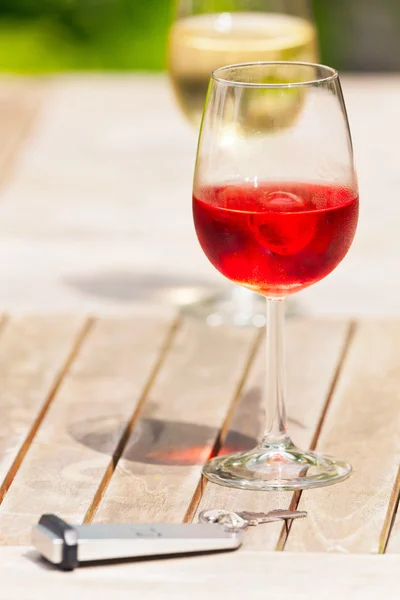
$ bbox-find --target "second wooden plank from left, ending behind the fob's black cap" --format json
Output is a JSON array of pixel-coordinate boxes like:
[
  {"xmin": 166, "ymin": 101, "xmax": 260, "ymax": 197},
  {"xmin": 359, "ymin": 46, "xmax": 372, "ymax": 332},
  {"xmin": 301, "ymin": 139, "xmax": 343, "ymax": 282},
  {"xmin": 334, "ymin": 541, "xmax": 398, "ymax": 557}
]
[{"xmin": 0, "ymin": 317, "xmax": 177, "ymax": 544}]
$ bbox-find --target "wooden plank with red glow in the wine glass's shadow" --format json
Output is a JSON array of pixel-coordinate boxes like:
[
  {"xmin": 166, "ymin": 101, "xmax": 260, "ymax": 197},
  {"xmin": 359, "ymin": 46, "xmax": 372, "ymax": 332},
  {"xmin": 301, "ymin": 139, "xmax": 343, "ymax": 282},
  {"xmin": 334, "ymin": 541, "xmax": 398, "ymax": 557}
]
[{"xmin": 91, "ymin": 319, "xmax": 259, "ymax": 522}]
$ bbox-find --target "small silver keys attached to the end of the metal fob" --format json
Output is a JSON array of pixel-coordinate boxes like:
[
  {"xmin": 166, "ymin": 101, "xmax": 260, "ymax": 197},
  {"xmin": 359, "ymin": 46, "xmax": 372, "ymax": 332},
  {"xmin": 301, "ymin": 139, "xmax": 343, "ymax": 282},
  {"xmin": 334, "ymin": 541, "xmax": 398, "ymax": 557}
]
[{"xmin": 199, "ymin": 509, "xmax": 307, "ymax": 531}]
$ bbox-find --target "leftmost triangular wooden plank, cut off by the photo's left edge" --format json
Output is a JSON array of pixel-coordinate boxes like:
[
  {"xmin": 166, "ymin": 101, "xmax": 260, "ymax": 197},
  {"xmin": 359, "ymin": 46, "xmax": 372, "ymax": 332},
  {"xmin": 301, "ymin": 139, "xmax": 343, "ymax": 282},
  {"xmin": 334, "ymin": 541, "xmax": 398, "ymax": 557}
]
[{"xmin": 0, "ymin": 317, "xmax": 85, "ymax": 504}]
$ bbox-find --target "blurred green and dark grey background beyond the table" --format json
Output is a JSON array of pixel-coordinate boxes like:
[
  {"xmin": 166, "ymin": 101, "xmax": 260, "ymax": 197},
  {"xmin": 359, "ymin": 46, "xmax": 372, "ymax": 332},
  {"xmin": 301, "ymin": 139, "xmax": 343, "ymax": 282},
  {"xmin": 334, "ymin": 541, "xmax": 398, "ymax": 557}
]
[{"xmin": 0, "ymin": 0, "xmax": 400, "ymax": 73}]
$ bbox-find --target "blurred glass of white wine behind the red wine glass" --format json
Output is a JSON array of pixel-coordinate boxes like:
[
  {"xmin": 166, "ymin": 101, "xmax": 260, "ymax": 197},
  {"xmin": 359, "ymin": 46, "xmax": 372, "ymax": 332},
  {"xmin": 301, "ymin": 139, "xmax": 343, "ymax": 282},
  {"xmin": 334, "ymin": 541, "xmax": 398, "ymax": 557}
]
[{"xmin": 168, "ymin": 0, "xmax": 318, "ymax": 326}]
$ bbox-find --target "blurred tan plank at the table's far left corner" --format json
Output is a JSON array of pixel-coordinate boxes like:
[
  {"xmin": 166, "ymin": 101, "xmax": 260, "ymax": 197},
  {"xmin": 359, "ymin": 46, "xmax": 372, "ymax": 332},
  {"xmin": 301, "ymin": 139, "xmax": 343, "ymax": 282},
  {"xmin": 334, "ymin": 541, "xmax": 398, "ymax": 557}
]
[{"xmin": 0, "ymin": 77, "xmax": 47, "ymax": 185}]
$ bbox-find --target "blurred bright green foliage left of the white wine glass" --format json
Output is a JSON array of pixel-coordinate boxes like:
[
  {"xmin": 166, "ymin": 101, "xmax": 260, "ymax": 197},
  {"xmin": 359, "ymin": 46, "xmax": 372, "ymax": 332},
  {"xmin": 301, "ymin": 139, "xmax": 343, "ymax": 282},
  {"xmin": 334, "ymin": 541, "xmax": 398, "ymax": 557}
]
[{"xmin": 0, "ymin": 0, "xmax": 172, "ymax": 72}]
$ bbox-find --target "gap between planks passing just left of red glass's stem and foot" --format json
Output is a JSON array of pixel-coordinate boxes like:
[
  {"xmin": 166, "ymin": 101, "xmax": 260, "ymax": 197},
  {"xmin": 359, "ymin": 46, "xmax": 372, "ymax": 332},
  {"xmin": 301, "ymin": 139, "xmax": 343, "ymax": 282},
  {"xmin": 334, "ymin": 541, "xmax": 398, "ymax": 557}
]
[{"xmin": 183, "ymin": 329, "xmax": 264, "ymax": 523}]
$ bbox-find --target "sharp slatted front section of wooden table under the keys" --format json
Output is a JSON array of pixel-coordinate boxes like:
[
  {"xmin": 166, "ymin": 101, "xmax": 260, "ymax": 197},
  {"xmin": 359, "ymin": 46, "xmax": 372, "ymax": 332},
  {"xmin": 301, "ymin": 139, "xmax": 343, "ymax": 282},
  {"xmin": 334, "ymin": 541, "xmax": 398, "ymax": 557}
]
[{"xmin": 0, "ymin": 311, "xmax": 400, "ymax": 600}]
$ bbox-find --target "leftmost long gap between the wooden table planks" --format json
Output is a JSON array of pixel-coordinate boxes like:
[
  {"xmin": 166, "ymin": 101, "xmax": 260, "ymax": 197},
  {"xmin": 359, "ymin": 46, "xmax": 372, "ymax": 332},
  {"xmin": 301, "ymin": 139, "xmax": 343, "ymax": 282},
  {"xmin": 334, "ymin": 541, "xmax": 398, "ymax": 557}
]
[{"xmin": 0, "ymin": 317, "xmax": 94, "ymax": 505}]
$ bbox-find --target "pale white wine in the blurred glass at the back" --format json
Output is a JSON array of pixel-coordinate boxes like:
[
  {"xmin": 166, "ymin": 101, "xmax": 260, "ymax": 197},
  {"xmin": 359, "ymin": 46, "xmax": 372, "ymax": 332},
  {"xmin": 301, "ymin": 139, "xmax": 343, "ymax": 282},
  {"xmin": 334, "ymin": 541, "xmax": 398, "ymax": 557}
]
[{"xmin": 169, "ymin": 12, "xmax": 317, "ymax": 128}]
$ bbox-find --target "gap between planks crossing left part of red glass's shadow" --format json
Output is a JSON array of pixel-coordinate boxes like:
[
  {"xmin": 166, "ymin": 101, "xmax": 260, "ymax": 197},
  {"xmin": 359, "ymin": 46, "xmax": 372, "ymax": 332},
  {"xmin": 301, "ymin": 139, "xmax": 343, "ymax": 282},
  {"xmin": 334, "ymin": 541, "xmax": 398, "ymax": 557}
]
[{"xmin": 83, "ymin": 315, "xmax": 183, "ymax": 523}]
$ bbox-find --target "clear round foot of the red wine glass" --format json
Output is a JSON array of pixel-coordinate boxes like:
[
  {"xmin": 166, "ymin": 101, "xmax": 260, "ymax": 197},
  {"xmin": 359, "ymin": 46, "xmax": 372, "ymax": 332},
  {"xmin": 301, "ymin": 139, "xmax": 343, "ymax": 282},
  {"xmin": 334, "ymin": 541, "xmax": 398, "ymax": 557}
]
[{"xmin": 203, "ymin": 441, "xmax": 352, "ymax": 491}]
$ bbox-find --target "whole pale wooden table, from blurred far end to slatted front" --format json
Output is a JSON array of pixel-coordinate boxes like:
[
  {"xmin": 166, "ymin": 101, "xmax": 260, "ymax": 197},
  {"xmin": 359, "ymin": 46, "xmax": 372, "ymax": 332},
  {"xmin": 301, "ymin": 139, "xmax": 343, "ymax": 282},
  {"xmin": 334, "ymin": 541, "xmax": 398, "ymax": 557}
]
[{"xmin": 0, "ymin": 75, "xmax": 400, "ymax": 600}]
